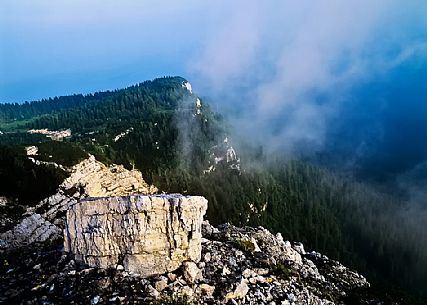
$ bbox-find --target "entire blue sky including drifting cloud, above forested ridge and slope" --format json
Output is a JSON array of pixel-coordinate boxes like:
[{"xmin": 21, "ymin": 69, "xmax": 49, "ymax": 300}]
[{"xmin": 0, "ymin": 0, "xmax": 427, "ymax": 183}]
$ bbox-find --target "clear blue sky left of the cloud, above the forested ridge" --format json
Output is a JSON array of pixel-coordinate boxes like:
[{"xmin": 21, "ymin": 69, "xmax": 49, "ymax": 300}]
[{"xmin": 0, "ymin": 0, "xmax": 216, "ymax": 102}]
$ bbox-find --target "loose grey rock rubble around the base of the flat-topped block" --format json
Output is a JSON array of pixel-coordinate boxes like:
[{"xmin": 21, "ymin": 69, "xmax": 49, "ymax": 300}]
[{"xmin": 0, "ymin": 215, "xmax": 388, "ymax": 305}]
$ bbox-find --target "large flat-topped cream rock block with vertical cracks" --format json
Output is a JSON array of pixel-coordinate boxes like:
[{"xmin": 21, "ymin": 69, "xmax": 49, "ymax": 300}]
[{"xmin": 64, "ymin": 195, "xmax": 207, "ymax": 276}]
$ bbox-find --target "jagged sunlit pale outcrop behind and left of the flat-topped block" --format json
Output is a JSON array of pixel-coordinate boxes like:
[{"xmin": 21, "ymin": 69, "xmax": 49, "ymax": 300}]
[{"xmin": 0, "ymin": 156, "xmax": 157, "ymax": 251}]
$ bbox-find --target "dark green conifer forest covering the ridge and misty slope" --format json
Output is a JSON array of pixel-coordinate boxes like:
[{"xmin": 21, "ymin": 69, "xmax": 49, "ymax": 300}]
[{"xmin": 0, "ymin": 77, "xmax": 427, "ymax": 304}]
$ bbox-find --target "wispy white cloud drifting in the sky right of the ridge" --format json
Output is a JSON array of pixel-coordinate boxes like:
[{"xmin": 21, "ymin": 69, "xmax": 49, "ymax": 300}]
[{"xmin": 191, "ymin": 0, "xmax": 424, "ymax": 152}]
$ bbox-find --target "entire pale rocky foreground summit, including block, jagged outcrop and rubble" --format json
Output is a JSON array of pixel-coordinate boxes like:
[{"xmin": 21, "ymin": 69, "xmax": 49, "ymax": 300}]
[{"xmin": 0, "ymin": 157, "xmax": 403, "ymax": 305}]
